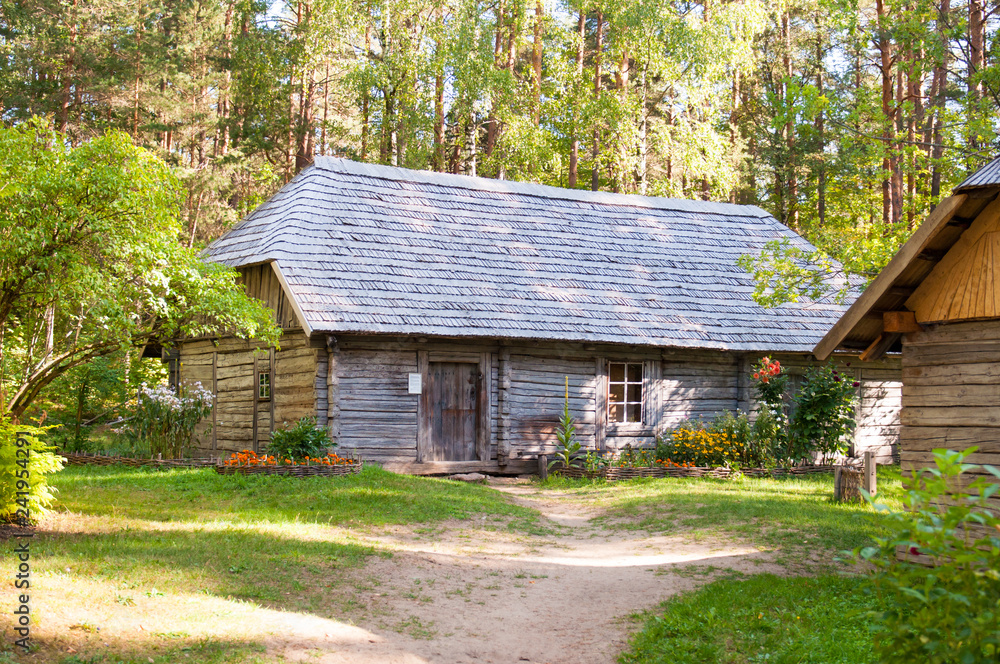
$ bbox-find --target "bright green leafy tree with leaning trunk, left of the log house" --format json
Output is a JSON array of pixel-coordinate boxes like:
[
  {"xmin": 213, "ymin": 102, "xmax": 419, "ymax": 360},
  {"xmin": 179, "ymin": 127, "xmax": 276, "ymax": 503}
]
[{"xmin": 0, "ymin": 120, "xmax": 278, "ymax": 417}]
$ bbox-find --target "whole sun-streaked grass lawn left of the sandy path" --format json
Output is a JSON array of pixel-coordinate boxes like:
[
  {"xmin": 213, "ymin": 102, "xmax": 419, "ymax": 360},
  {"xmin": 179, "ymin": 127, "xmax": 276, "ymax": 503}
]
[{"xmin": 0, "ymin": 466, "xmax": 540, "ymax": 664}]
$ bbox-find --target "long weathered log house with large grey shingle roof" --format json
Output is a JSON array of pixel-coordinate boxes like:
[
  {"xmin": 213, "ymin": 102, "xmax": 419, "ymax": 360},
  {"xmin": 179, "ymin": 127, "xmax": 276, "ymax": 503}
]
[{"xmin": 172, "ymin": 157, "xmax": 899, "ymax": 473}]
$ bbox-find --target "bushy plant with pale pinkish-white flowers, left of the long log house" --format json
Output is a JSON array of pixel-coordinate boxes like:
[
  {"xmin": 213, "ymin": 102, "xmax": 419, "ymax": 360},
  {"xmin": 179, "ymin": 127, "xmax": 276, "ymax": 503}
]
[{"xmin": 117, "ymin": 383, "xmax": 214, "ymax": 459}]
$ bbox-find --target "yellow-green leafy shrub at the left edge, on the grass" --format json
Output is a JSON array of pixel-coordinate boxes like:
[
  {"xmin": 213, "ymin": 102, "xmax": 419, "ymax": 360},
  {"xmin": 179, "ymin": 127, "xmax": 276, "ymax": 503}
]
[{"xmin": 0, "ymin": 416, "xmax": 63, "ymax": 523}]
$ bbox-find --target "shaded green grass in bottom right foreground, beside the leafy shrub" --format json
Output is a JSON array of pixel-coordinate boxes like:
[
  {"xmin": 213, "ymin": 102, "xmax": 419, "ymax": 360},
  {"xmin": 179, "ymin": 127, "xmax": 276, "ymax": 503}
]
[{"xmin": 618, "ymin": 574, "xmax": 883, "ymax": 664}]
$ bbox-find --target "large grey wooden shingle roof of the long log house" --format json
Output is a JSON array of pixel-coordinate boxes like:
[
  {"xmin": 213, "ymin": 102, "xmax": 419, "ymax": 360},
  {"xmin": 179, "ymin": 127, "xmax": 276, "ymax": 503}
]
[{"xmin": 206, "ymin": 157, "xmax": 846, "ymax": 352}]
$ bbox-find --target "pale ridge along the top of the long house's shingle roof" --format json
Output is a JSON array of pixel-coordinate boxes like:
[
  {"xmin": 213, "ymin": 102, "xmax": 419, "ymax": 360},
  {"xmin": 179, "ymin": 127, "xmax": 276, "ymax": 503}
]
[{"xmin": 313, "ymin": 156, "xmax": 771, "ymax": 217}]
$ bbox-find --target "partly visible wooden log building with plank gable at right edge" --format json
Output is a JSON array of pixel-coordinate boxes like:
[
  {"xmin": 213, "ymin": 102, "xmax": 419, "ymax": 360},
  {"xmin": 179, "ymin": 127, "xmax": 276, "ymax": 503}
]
[{"xmin": 815, "ymin": 159, "xmax": 1000, "ymax": 492}]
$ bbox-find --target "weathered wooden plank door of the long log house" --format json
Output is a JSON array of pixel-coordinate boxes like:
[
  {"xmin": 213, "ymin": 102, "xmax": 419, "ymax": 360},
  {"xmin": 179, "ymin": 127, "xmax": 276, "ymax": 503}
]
[{"xmin": 422, "ymin": 362, "xmax": 479, "ymax": 461}]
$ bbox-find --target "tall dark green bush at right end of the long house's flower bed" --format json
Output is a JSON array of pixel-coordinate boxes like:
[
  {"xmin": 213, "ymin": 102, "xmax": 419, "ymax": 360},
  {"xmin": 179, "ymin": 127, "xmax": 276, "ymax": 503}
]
[{"xmin": 784, "ymin": 364, "xmax": 858, "ymax": 461}]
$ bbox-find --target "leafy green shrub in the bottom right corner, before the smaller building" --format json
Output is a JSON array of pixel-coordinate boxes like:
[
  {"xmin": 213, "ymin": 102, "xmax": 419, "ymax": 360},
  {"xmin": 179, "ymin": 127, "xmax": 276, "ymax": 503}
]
[{"xmin": 854, "ymin": 447, "xmax": 1000, "ymax": 664}]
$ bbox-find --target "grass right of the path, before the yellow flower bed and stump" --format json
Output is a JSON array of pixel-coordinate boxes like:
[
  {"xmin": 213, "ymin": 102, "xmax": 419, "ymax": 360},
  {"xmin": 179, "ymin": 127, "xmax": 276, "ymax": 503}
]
[{"xmin": 543, "ymin": 466, "xmax": 902, "ymax": 552}]
